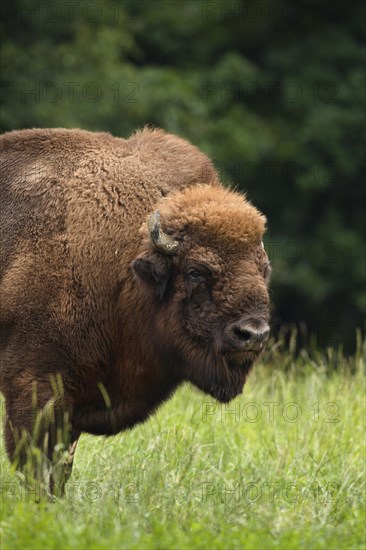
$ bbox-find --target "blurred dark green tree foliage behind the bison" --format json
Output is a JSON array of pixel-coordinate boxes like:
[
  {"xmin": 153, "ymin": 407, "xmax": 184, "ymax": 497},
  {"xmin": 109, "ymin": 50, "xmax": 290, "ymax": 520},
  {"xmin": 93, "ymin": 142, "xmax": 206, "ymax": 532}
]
[{"xmin": 1, "ymin": 0, "xmax": 366, "ymax": 348}]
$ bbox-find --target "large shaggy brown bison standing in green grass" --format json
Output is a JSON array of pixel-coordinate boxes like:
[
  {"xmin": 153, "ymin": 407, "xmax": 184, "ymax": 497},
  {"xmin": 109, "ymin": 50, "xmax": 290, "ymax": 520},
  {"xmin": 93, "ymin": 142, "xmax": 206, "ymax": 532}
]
[{"xmin": 0, "ymin": 128, "xmax": 270, "ymax": 493}]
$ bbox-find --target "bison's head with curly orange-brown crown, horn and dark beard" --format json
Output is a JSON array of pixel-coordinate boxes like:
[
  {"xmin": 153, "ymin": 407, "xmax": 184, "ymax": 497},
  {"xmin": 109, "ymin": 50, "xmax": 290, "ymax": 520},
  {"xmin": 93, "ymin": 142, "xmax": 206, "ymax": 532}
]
[{"xmin": 132, "ymin": 185, "xmax": 270, "ymax": 402}]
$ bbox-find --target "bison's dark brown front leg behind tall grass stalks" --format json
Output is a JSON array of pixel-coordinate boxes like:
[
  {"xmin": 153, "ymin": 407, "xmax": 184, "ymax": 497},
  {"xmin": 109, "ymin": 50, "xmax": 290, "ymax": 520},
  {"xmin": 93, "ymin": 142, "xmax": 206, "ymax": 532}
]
[{"xmin": 5, "ymin": 387, "xmax": 80, "ymax": 496}]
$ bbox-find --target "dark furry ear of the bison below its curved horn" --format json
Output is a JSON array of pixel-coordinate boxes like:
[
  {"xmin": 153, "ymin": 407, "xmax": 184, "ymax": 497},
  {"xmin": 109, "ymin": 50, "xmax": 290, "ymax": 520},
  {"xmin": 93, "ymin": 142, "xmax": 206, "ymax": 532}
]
[{"xmin": 132, "ymin": 252, "xmax": 172, "ymax": 300}]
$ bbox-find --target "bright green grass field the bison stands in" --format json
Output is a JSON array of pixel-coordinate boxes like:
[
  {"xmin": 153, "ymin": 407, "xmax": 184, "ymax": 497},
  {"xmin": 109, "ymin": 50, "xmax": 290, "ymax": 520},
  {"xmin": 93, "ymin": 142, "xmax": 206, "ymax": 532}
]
[{"xmin": 0, "ymin": 338, "xmax": 365, "ymax": 550}]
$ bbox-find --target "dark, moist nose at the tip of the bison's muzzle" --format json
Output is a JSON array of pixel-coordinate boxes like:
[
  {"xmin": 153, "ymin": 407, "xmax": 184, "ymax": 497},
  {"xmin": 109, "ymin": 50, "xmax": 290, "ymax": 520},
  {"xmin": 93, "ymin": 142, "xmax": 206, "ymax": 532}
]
[{"xmin": 225, "ymin": 319, "xmax": 269, "ymax": 351}]
